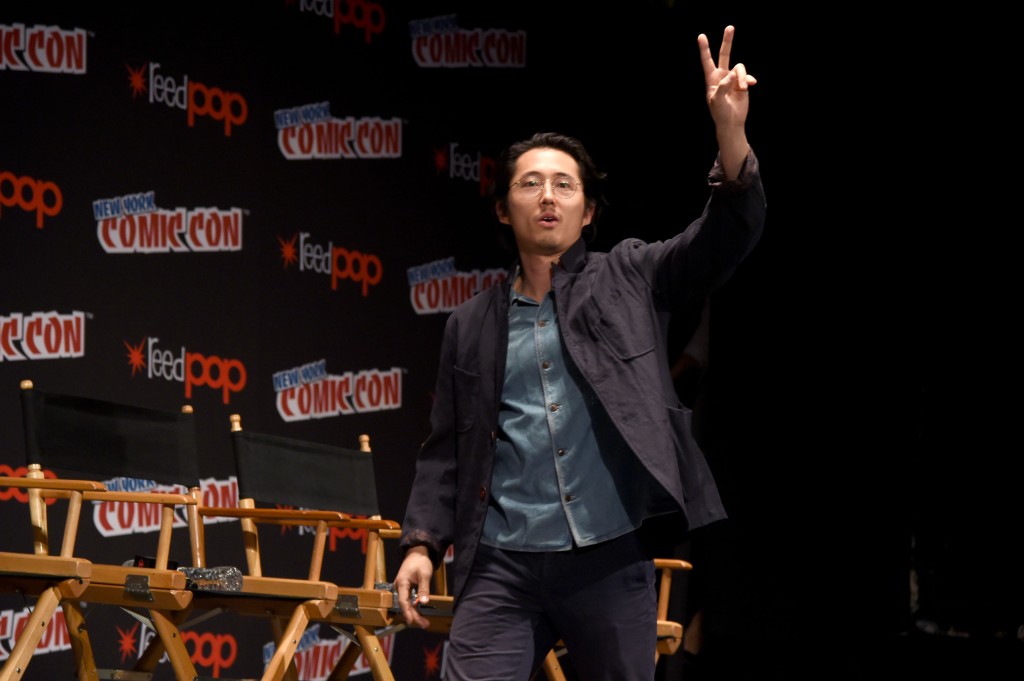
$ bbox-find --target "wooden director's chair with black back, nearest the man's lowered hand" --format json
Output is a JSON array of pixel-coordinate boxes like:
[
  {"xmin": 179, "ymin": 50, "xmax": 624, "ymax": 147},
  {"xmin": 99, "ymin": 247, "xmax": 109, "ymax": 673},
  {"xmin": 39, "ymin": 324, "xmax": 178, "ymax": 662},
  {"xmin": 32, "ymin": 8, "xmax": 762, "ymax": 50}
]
[{"xmin": 178, "ymin": 415, "xmax": 399, "ymax": 681}]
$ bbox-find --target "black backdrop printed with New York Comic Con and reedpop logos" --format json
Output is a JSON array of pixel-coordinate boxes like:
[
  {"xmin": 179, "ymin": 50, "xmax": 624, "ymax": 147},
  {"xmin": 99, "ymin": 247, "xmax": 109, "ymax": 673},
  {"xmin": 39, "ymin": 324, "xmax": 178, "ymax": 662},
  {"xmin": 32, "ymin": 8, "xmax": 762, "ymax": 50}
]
[{"xmin": 0, "ymin": 0, "xmax": 786, "ymax": 680}]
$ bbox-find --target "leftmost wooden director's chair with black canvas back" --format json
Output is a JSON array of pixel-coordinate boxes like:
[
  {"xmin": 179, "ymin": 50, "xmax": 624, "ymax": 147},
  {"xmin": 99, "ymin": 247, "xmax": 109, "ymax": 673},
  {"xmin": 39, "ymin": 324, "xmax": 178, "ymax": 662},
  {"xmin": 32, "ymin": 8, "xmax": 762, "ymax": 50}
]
[{"xmin": 0, "ymin": 381, "xmax": 199, "ymax": 681}]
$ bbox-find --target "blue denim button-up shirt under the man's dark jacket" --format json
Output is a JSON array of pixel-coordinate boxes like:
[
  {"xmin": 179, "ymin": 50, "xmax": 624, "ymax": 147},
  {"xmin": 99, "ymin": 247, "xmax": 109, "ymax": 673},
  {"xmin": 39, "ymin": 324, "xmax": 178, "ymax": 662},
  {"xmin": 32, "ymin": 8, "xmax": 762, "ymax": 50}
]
[{"xmin": 480, "ymin": 276, "xmax": 671, "ymax": 551}]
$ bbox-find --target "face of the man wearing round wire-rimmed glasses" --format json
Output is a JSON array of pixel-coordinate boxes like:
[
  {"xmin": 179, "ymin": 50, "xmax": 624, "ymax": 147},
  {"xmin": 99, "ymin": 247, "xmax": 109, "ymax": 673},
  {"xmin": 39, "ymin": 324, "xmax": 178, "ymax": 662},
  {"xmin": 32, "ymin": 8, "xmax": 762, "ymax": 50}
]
[{"xmin": 498, "ymin": 147, "xmax": 594, "ymax": 256}]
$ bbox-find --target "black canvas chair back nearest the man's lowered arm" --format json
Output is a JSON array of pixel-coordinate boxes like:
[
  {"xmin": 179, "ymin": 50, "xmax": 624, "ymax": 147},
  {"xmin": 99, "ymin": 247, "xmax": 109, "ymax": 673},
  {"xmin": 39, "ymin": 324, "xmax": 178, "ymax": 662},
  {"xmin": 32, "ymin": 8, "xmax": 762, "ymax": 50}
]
[{"xmin": 231, "ymin": 420, "xmax": 380, "ymax": 516}]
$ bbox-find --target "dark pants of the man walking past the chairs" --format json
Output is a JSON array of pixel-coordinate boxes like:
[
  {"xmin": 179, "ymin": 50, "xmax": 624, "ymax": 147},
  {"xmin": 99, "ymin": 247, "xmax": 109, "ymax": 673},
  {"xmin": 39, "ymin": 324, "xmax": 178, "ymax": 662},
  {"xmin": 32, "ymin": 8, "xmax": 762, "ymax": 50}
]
[{"xmin": 444, "ymin": 534, "xmax": 657, "ymax": 681}]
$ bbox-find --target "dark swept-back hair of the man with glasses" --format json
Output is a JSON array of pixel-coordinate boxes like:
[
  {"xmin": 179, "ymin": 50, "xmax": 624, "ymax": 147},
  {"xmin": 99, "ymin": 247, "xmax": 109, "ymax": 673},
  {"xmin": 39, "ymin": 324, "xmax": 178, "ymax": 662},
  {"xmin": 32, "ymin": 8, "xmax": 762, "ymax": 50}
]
[{"xmin": 492, "ymin": 132, "xmax": 608, "ymax": 243}]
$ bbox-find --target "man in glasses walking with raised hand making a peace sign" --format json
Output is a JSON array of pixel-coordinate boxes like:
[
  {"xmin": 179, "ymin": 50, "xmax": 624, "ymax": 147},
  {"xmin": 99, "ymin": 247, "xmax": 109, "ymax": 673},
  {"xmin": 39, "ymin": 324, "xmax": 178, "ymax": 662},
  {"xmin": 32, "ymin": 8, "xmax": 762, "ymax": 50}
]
[{"xmin": 395, "ymin": 27, "xmax": 765, "ymax": 681}]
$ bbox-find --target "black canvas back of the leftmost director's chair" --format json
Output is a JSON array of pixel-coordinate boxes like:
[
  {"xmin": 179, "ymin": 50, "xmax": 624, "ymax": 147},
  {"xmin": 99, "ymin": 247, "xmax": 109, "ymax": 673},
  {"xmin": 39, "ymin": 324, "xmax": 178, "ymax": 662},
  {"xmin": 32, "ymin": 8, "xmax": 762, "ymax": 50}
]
[{"xmin": 22, "ymin": 381, "xmax": 200, "ymax": 488}]
